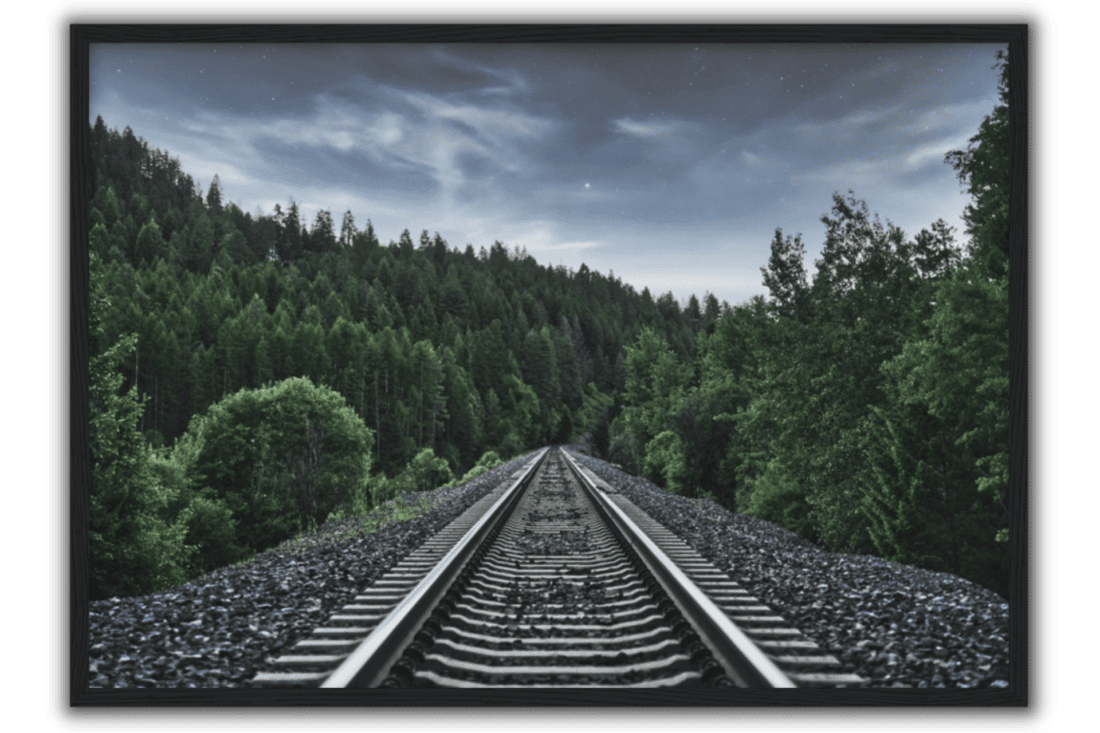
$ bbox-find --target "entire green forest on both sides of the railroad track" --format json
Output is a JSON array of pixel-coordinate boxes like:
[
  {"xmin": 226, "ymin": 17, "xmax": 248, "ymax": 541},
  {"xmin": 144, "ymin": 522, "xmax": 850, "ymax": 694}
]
[{"xmin": 87, "ymin": 54, "xmax": 1009, "ymax": 599}]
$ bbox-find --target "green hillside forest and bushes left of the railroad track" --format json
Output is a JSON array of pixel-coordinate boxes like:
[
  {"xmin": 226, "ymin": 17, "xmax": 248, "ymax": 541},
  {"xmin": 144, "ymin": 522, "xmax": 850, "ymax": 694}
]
[{"xmin": 89, "ymin": 112, "xmax": 719, "ymax": 597}]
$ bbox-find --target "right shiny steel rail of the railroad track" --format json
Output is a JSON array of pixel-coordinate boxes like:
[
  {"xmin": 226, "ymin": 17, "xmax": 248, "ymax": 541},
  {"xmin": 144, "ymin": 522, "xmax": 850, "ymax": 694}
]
[{"xmin": 560, "ymin": 448, "xmax": 798, "ymax": 688}]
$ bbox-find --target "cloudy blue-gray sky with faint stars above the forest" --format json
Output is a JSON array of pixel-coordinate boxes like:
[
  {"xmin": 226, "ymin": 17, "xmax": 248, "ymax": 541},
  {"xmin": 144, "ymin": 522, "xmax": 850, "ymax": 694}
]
[{"xmin": 89, "ymin": 43, "xmax": 1007, "ymax": 305}]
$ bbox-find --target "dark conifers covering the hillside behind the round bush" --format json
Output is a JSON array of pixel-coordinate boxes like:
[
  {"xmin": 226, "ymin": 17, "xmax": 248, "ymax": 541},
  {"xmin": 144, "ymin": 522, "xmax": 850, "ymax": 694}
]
[{"xmin": 83, "ymin": 119, "xmax": 704, "ymax": 474}]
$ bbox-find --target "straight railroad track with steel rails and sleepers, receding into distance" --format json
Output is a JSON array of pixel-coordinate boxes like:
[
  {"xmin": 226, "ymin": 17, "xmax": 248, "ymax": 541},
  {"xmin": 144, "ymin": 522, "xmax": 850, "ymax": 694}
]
[{"xmin": 252, "ymin": 448, "xmax": 865, "ymax": 688}]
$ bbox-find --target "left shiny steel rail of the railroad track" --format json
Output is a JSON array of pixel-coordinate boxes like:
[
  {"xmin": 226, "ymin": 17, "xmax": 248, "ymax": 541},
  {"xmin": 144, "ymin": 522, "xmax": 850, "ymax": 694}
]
[{"xmin": 320, "ymin": 447, "xmax": 550, "ymax": 688}]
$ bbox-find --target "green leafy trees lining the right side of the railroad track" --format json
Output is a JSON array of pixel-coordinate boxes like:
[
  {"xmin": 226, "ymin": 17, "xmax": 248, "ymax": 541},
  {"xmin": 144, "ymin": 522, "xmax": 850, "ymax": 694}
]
[{"xmin": 609, "ymin": 48, "xmax": 1009, "ymax": 597}]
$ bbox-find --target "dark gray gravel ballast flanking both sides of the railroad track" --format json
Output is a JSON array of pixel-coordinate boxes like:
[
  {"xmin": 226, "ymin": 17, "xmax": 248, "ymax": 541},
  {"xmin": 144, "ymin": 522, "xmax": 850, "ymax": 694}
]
[{"xmin": 88, "ymin": 442, "xmax": 1009, "ymax": 688}]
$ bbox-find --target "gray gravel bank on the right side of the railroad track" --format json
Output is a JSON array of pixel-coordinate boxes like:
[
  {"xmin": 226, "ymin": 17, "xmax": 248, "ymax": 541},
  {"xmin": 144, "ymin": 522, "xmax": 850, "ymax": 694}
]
[{"xmin": 573, "ymin": 442, "xmax": 1009, "ymax": 688}]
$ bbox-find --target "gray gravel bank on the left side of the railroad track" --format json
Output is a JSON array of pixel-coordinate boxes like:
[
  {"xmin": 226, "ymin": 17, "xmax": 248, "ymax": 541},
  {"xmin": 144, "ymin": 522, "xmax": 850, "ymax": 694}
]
[{"xmin": 88, "ymin": 456, "xmax": 528, "ymax": 688}]
